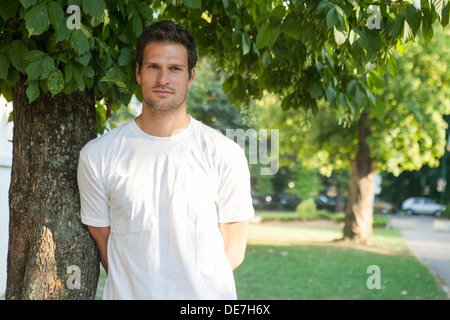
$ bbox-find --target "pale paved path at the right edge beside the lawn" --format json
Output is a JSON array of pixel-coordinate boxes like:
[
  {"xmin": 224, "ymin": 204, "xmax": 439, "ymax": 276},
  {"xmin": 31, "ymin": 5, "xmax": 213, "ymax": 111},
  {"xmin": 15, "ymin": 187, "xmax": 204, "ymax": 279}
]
[{"xmin": 390, "ymin": 216, "xmax": 450, "ymax": 299}]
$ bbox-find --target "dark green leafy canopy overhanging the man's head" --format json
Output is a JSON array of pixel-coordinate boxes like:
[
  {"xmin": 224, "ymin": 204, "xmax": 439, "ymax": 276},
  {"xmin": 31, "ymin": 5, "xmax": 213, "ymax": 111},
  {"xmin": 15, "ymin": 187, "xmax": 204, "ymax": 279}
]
[{"xmin": 0, "ymin": 0, "xmax": 449, "ymax": 120}]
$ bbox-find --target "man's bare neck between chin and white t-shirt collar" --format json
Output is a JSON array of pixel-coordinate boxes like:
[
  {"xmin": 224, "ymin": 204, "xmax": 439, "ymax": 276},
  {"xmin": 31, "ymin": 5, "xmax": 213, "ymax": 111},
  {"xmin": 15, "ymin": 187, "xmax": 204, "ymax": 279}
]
[{"xmin": 136, "ymin": 106, "xmax": 190, "ymax": 137}]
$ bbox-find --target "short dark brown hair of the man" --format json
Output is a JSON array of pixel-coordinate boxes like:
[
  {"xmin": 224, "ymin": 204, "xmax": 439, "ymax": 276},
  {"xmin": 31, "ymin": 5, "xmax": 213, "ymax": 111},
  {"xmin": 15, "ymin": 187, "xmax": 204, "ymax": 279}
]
[{"xmin": 136, "ymin": 20, "xmax": 198, "ymax": 78}]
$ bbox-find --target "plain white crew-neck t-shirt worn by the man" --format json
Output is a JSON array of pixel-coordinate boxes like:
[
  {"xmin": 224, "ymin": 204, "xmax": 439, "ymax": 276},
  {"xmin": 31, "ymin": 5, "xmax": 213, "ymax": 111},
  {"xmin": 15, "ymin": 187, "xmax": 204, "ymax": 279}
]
[{"xmin": 78, "ymin": 117, "xmax": 254, "ymax": 299}]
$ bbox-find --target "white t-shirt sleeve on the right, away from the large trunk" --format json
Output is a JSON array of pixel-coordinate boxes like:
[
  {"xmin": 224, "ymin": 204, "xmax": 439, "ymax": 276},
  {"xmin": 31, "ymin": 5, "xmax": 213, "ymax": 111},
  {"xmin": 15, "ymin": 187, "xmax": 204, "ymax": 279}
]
[{"xmin": 217, "ymin": 144, "xmax": 255, "ymax": 223}]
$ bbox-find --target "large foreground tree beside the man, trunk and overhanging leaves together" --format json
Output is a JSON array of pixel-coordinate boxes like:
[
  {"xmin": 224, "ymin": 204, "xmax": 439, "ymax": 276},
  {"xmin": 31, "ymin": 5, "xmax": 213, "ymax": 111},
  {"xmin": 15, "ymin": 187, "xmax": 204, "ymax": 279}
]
[{"xmin": 0, "ymin": 0, "xmax": 449, "ymax": 299}]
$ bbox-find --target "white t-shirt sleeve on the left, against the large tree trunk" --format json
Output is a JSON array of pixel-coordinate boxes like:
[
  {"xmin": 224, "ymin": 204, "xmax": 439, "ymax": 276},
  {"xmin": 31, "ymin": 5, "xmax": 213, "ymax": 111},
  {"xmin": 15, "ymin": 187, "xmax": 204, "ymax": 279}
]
[{"xmin": 77, "ymin": 149, "xmax": 110, "ymax": 227}]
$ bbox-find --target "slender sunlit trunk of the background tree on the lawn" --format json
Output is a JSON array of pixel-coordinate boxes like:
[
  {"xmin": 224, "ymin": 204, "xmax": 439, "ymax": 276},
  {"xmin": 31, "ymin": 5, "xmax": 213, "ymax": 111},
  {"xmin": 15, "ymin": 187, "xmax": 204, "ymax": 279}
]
[{"xmin": 344, "ymin": 113, "xmax": 375, "ymax": 245}]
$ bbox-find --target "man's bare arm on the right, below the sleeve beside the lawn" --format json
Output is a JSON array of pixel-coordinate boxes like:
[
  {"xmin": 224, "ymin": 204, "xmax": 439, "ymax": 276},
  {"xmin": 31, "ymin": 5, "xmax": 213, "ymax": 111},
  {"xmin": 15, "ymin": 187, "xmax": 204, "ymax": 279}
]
[{"xmin": 219, "ymin": 220, "xmax": 249, "ymax": 270}]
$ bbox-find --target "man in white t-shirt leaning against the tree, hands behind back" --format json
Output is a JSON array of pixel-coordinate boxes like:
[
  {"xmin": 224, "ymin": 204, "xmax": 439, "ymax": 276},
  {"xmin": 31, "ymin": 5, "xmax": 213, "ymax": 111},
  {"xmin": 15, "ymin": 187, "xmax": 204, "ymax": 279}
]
[{"xmin": 78, "ymin": 21, "xmax": 254, "ymax": 299}]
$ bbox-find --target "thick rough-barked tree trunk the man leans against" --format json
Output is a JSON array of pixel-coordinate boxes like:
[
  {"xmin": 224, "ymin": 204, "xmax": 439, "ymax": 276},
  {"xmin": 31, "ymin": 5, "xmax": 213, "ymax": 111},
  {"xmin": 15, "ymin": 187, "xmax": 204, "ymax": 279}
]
[{"xmin": 6, "ymin": 82, "xmax": 99, "ymax": 300}]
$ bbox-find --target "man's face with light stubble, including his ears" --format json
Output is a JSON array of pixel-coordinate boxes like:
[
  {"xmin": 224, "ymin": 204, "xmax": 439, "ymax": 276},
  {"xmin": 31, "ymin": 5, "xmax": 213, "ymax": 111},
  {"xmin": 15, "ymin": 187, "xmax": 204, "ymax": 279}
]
[{"xmin": 136, "ymin": 42, "xmax": 195, "ymax": 112}]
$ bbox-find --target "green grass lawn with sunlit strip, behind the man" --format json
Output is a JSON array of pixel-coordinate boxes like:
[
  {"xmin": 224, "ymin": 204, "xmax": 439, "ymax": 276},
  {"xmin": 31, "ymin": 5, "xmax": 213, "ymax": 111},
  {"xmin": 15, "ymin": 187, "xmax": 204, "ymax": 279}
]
[{"xmin": 97, "ymin": 215, "xmax": 446, "ymax": 300}]
